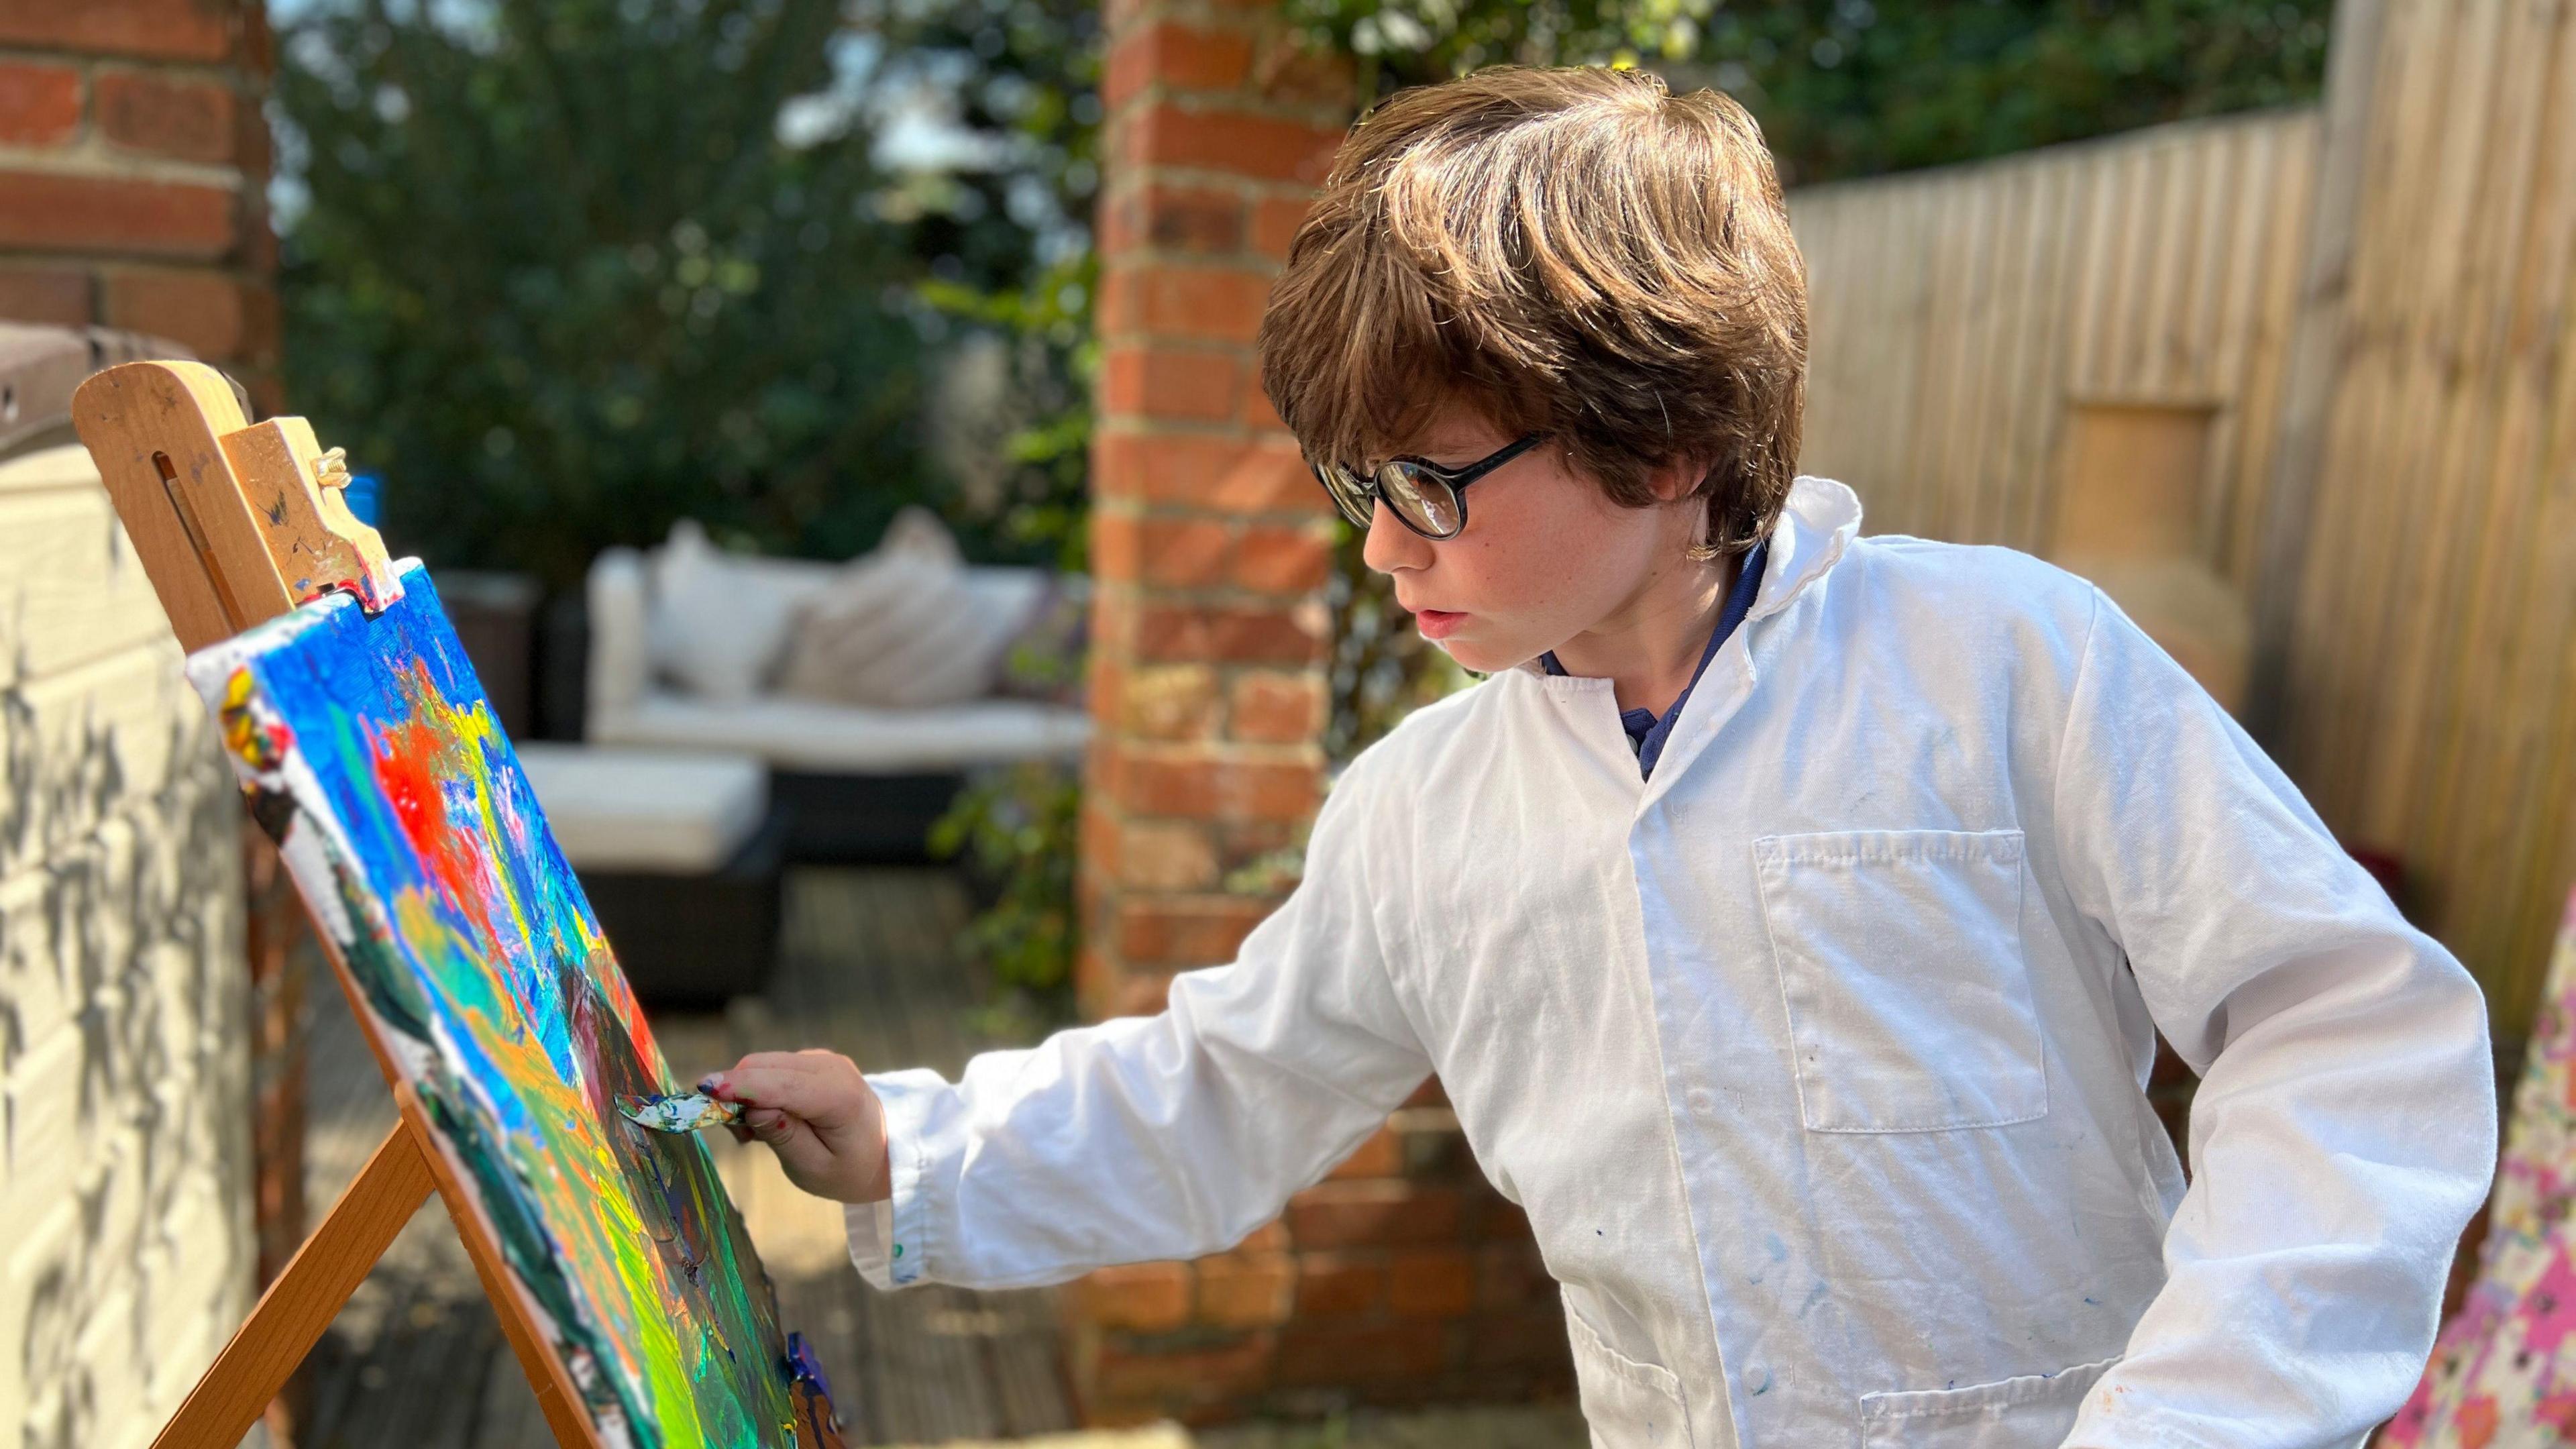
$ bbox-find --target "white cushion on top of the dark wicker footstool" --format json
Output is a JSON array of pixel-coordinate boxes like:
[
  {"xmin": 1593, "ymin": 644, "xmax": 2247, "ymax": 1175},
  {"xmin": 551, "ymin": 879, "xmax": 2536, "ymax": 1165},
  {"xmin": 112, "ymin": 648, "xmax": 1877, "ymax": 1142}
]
[{"xmin": 518, "ymin": 743, "xmax": 770, "ymax": 874}]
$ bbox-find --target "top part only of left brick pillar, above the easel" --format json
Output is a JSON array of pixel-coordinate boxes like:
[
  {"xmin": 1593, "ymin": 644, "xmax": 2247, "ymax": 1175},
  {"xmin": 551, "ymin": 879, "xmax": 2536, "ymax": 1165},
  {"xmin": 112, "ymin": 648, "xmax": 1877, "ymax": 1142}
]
[{"xmin": 0, "ymin": 0, "xmax": 278, "ymax": 410}]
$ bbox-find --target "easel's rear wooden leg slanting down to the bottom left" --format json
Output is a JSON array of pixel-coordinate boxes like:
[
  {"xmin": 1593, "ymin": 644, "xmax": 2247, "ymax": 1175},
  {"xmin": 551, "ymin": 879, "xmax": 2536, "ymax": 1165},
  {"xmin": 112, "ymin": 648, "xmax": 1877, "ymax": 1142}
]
[{"xmin": 152, "ymin": 1122, "xmax": 430, "ymax": 1449}]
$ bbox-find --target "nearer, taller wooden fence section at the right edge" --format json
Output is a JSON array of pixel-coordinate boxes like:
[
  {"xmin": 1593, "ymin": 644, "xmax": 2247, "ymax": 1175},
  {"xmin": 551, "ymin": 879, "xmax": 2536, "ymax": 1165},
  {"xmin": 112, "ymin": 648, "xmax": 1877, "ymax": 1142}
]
[{"xmin": 2277, "ymin": 0, "xmax": 2576, "ymax": 1039}]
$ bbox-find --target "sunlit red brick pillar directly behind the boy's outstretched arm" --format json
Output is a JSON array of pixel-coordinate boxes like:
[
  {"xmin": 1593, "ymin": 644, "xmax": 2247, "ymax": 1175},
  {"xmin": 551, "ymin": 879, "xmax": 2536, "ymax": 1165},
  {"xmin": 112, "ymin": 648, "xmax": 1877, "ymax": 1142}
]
[{"xmin": 1064, "ymin": 0, "xmax": 1571, "ymax": 1424}]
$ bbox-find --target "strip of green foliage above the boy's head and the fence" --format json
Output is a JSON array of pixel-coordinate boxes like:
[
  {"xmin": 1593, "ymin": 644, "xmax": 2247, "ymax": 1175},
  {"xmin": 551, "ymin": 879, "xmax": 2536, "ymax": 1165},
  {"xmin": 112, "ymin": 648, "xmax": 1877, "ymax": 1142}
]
[{"xmin": 1288, "ymin": 0, "xmax": 2334, "ymax": 186}]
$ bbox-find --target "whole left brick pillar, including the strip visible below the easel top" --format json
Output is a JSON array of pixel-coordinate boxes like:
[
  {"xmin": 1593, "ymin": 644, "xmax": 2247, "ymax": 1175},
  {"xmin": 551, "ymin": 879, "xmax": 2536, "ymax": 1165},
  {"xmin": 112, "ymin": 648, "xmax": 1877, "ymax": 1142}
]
[{"xmin": 0, "ymin": 0, "xmax": 307, "ymax": 1441}]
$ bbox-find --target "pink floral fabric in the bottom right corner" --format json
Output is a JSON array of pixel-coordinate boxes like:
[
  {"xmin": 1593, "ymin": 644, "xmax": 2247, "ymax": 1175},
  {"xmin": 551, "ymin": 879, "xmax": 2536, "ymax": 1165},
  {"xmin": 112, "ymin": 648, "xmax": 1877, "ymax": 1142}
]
[{"xmin": 2380, "ymin": 895, "xmax": 2576, "ymax": 1449}]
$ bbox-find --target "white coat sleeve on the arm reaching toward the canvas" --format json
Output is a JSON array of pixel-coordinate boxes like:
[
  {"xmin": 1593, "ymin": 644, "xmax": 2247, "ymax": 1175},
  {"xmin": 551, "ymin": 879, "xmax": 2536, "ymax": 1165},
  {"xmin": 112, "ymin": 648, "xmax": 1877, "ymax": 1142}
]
[{"xmin": 847, "ymin": 761, "xmax": 1430, "ymax": 1289}]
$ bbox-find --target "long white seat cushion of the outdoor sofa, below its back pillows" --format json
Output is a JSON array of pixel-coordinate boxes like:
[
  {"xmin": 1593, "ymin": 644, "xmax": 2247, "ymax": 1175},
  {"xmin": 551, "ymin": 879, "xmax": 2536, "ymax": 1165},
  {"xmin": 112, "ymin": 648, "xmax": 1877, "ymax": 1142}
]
[{"xmin": 590, "ymin": 691, "xmax": 1092, "ymax": 773}]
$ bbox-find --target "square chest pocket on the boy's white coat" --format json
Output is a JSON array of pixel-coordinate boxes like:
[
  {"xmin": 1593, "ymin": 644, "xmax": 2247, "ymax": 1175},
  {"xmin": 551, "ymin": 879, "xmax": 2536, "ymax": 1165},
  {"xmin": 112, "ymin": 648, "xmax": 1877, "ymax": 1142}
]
[{"xmin": 1754, "ymin": 830, "xmax": 2048, "ymax": 1132}]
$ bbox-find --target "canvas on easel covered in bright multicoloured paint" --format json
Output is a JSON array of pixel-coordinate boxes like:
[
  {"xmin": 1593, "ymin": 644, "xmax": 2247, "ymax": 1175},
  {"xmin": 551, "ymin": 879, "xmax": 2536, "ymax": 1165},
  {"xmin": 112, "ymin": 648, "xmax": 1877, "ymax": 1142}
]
[{"xmin": 188, "ymin": 562, "xmax": 832, "ymax": 1449}]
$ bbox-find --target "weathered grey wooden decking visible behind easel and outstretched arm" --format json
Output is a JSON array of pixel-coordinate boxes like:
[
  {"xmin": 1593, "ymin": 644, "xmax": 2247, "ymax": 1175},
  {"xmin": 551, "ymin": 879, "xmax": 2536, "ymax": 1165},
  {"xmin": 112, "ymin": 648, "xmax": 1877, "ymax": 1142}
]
[{"xmin": 301, "ymin": 871, "xmax": 1071, "ymax": 1449}]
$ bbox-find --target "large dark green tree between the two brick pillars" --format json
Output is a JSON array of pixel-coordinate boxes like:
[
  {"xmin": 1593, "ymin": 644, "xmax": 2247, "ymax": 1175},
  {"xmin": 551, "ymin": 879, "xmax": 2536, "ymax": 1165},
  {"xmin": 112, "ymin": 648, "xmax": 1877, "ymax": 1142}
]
[{"xmin": 276, "ymin": 0, "xmax": 930, "ymax": 585}]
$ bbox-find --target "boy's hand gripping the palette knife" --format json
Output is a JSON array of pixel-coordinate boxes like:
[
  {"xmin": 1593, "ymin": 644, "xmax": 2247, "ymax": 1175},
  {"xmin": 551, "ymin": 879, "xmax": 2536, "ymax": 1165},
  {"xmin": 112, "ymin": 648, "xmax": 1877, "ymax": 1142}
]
[{"xmin": 698, "ymin": 1052, "xmax": 894, "ymax": 1201}]
